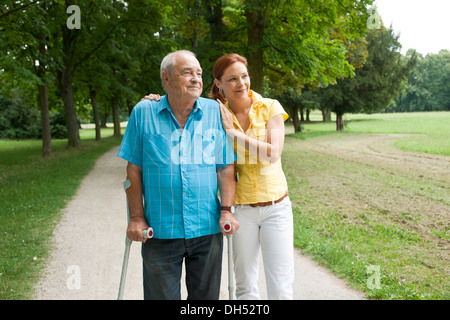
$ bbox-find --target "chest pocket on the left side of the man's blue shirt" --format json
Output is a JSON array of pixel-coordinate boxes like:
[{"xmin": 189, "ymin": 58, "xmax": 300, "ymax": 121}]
[{"xmin": 143, "ymin": 134, "xmax": 172, "ymax": 168}]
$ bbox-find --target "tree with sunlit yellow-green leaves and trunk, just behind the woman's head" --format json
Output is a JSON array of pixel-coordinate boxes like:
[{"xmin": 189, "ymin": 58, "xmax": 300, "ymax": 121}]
[{"xmin": 244, "ymin": 0, "xmax": 373, "ymax": 93}]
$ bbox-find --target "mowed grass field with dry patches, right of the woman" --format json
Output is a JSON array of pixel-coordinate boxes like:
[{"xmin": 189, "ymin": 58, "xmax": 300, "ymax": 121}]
[{"xmin": 283, "ymin": 112, "xmax": 450, "ymax": 299}]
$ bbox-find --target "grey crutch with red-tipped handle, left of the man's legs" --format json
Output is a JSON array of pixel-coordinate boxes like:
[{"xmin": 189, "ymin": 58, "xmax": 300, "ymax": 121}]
[{"xmin": 117, "ymin": 180, "xmax": 153, "ymax": 300}]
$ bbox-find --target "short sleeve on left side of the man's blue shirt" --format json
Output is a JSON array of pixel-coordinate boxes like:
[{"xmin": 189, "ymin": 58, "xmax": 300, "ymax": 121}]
[{"xmin": 117, "ymin": 108, "xmax": 142, "ymax": 167}]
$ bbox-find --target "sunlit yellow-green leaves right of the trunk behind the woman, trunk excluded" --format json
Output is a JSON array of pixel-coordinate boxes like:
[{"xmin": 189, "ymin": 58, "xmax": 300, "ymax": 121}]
[{"xmin": 256, "ymin": 0, "xmax": 372, "ymax": 91}]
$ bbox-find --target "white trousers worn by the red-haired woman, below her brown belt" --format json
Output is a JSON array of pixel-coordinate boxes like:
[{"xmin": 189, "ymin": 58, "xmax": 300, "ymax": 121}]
[{"xmin": 233, "ymin": 197, "xmax": 294, "ymax": 300}]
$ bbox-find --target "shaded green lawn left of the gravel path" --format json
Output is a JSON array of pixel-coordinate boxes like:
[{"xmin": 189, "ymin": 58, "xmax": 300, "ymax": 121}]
[{"xmin": 0, "ymin": 129, "xmax": 121, "ymax": 300}]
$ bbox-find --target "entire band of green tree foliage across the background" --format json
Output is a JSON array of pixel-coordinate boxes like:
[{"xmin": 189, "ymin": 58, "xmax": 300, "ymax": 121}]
[{"xmin": 0, "ymin": 0, "xmax": 436, "ymax": 142}]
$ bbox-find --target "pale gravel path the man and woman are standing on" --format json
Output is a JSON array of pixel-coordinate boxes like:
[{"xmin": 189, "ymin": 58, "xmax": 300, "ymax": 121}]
[{"xmin": 34, "ymin": 148, "xmax": 364, "ymax": 300}]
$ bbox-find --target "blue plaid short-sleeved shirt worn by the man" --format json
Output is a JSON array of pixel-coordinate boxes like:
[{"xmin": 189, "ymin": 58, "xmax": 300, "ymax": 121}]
[{"xmin": 117, "ymin": 96, "xmax": 236, "ymax": 239}]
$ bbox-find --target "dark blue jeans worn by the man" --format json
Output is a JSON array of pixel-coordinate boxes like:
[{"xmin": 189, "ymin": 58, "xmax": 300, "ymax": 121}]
[{"xmin": 142, "ymin": 233, "xmax": 223, "ymax": 300}]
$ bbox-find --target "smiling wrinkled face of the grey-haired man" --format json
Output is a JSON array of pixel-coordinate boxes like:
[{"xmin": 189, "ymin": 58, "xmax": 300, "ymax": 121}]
[{"xmin": 163, "ymin": 54, "xmax": 203, "ymax": 100}]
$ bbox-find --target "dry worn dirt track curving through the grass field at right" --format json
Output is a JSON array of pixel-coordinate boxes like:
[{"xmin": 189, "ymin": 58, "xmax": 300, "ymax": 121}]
[{"xmin": 286, "ymin": 134, "xmax": 450, "ymax": 235}]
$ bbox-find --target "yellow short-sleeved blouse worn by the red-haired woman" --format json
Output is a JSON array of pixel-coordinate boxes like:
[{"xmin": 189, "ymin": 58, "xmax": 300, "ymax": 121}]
[{"xmin": 225, "ymin": 90, "xmax": 289, "ymax": 204}]
